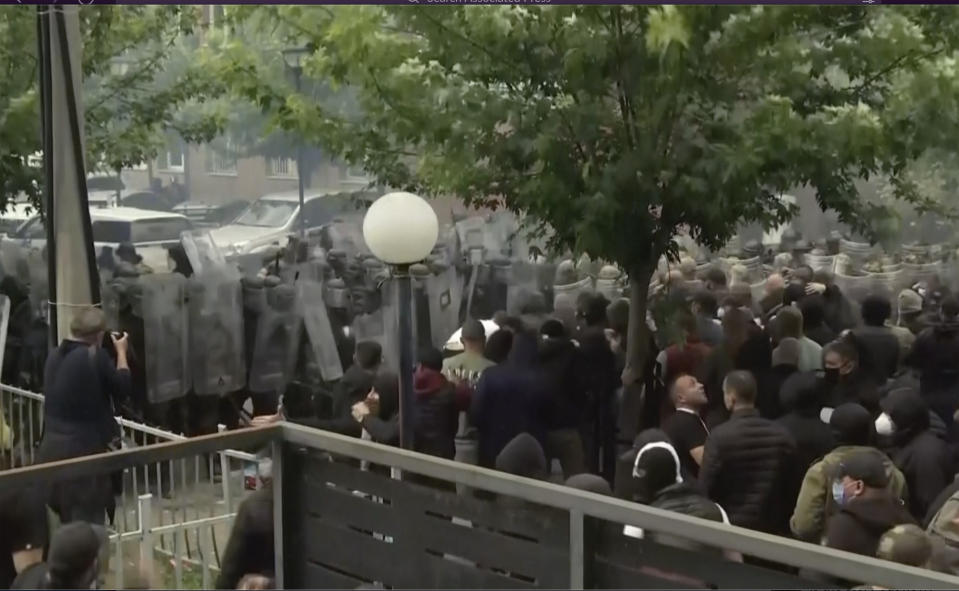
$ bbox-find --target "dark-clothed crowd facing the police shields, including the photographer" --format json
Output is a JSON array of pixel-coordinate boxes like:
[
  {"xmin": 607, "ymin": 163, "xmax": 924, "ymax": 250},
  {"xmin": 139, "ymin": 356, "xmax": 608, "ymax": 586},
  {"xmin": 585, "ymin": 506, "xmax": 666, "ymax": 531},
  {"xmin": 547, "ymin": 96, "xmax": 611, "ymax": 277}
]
[{"xmin": 9, "ymin": 240, "xmax": 959, "ymax": 588}]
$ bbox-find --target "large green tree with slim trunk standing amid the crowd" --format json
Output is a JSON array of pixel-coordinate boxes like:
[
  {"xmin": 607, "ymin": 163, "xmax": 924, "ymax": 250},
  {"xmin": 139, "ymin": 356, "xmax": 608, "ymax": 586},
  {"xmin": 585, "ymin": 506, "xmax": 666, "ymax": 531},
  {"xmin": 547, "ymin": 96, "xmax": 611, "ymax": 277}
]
[{"xmin": 231, "ymin": 6, "xmax": 959, "ymax": 380}]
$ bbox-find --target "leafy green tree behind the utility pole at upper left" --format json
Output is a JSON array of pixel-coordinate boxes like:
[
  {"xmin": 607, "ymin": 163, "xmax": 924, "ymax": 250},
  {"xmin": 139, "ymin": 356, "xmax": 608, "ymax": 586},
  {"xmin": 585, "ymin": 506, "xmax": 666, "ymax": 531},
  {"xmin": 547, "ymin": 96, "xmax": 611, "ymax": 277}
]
[{"xmin": 0, "ymin": 6, "xmax": 224, "ymax": 211}]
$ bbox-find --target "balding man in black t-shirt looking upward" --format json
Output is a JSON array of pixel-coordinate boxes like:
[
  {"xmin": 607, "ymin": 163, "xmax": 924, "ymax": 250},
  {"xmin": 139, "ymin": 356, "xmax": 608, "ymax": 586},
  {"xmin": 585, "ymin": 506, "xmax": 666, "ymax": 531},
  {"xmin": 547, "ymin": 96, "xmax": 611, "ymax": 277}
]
[{"xmin": 662, "ymin": 375, "xmax": 709, "ymax": 479}]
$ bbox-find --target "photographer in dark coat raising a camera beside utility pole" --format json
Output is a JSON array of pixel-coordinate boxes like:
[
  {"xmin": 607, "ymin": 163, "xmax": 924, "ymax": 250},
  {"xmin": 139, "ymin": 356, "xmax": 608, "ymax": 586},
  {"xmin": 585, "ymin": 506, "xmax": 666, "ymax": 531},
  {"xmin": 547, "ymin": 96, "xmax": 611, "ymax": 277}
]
[{"xmin": 38, "ymin": 306, "xmax": 130, "ymax": 524}]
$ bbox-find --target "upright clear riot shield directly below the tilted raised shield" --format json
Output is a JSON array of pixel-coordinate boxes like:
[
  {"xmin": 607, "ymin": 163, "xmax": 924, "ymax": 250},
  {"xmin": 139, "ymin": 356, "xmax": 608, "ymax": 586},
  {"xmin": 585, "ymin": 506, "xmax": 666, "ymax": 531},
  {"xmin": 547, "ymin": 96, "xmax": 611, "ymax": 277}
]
[{"xmin": 188, "ymin": 271, "xmax": 246, "ymax": 396}]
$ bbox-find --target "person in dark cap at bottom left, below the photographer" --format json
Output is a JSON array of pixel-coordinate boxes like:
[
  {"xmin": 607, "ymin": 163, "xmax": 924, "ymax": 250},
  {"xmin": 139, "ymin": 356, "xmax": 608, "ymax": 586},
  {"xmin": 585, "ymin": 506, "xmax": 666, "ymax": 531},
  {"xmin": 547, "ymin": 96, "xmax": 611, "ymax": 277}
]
[{"xmin": 10, "ymin": 521, "xmax": 108, "ymax": 589}]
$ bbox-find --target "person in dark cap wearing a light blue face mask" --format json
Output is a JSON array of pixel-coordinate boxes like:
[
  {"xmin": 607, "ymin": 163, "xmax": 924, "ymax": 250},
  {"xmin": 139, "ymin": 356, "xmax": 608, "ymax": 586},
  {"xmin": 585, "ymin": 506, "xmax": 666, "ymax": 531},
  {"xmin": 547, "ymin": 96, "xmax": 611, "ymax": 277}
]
[{"xmin": 826, "ymin": 453, "xmax": 916, "ymax": 556}]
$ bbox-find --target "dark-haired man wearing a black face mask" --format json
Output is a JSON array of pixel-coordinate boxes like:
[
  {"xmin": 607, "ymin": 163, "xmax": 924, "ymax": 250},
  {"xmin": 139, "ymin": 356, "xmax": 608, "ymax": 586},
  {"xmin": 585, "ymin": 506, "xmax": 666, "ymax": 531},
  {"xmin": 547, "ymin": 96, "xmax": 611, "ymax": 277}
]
[{"xmin": 823, "ymin": 339, "xmax": 880, "ymax": 416}]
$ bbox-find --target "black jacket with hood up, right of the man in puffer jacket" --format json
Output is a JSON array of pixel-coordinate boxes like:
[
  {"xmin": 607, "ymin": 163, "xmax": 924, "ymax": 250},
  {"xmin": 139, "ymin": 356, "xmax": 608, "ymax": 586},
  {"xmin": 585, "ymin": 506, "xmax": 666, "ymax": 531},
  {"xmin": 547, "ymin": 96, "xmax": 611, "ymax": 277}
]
[{"xmin": 777, "ymin": 373, "xmax": 836, "ymax": 471}]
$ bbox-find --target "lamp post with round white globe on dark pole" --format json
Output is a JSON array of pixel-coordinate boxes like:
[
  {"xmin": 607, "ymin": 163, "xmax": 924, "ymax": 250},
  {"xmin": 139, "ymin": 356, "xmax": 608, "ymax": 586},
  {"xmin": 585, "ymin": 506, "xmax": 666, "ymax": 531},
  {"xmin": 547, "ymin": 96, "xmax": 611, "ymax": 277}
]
[{"xmin": 363, "ymin": 192, "xmax": 439, "ymax": 449}]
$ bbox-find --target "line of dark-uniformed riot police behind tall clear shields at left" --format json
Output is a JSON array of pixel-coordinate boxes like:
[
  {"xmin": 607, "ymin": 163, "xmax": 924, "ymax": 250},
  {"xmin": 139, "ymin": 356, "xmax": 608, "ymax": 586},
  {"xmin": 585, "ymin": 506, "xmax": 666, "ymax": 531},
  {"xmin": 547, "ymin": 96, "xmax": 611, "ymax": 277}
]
[{"xmin": 0, "ymin": 213, "xmax": 632, "ymax": 442}]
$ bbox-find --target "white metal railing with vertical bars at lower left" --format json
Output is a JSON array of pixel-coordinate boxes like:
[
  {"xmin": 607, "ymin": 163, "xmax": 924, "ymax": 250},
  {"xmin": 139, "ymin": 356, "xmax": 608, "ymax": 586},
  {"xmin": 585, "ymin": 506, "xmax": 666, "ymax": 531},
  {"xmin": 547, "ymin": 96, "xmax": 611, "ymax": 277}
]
[{"xmin": 0, "ymin": 384, "xmax": 259, "ymax": 588}]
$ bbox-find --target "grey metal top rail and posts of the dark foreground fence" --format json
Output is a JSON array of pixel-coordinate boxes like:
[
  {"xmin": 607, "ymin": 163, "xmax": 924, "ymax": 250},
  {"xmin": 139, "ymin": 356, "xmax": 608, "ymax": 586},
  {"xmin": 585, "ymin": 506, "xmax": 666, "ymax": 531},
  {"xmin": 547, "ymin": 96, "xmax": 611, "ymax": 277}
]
[{"xmin": 0, "ymin": 423, "xmax": 959, "ymax": 589}]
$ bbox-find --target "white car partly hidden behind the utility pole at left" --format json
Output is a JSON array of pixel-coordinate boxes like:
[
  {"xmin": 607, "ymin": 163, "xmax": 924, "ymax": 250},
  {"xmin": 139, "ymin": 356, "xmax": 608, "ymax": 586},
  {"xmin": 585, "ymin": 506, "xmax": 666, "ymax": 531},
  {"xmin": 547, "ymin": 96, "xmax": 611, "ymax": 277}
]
[{"xmin": 11, "ymin": 207, "xmax": 193, "ymax": 272}]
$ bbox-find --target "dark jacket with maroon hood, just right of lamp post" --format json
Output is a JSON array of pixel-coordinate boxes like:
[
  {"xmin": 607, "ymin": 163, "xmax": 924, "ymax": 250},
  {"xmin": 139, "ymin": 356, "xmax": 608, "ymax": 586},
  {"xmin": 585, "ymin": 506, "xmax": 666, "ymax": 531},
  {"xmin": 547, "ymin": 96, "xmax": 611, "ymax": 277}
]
[{"xmin": 413, "ymin": 367, "xmax": 459, "ymax": 460}]
